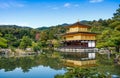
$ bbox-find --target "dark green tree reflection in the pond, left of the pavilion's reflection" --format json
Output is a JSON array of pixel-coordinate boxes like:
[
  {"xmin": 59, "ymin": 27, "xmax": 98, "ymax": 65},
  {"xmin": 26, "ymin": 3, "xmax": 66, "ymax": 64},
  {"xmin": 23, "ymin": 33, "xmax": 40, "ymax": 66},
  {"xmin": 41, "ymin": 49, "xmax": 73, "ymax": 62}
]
[{"xmin": 0, "ymin": 54, "xmax": 63, "ymax": 72}]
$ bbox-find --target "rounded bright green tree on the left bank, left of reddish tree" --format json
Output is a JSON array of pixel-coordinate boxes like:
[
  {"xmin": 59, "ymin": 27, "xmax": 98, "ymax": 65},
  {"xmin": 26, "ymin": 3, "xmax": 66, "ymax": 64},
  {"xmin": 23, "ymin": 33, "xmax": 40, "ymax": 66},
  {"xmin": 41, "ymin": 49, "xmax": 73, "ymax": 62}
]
[{"xmin": 20, "ymin": 36, "xmax": 32, "ymax": 49}]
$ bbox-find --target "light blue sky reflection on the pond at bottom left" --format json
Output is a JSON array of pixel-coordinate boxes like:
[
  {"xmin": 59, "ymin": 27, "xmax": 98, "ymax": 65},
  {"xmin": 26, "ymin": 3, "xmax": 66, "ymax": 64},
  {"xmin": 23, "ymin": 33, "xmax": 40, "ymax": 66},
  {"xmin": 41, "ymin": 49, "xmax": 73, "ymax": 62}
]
[{"xmin": 0, "ymin": 66, "xmax": 65, "ymax": 78}]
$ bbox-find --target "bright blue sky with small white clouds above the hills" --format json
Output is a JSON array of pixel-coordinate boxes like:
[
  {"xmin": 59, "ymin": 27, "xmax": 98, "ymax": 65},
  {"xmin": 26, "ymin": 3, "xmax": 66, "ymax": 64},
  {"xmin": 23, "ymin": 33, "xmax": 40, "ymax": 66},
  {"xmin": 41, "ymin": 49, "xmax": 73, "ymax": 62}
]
[{"xmin": 0, "ymin": 0, "xmax": 120, "ymax": 28}]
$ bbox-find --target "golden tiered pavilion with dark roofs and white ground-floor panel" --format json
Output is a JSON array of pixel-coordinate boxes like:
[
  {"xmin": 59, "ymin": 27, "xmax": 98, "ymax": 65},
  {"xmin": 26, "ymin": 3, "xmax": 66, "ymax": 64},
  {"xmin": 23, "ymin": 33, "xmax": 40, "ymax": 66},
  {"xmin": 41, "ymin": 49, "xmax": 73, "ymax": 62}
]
[{"xmin": 63, "ymin": 22, "xmax": 96, "ymax": 48}]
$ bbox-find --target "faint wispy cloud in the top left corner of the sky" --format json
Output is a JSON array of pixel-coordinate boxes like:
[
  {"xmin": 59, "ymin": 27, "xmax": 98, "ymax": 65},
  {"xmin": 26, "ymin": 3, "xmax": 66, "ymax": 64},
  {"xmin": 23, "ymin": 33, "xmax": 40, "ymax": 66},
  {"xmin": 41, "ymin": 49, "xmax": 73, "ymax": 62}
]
[{"xmin": 0, "ymin": 2, "xmax": 25, "ymax": 8}]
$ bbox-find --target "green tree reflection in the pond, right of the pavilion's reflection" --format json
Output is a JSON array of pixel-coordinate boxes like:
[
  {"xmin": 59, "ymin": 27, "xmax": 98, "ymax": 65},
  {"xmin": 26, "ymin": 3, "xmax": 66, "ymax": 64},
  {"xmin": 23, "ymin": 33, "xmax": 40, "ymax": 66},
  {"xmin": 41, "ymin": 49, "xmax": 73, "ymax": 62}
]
[{"xmin": 96, "ymin": 54, "xmax": 120, "ymax": 75}]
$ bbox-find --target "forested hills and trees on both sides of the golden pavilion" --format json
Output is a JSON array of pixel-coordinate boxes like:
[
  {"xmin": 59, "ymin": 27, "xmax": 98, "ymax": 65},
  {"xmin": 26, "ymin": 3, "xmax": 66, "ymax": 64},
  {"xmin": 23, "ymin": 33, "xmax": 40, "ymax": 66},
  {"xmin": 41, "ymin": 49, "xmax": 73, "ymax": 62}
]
[{"xmin": 0, "ymin": 5, "xmax": 120, "ymax": 52}]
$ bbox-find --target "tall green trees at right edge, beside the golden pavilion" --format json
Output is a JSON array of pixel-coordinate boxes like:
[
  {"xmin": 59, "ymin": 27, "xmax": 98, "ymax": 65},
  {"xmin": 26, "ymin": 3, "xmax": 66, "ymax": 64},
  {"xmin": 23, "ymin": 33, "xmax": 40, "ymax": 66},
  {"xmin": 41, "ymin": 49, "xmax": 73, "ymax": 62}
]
[{"xmin": 96, "ymin": 6, "xmax": 120, "ymax": 52}]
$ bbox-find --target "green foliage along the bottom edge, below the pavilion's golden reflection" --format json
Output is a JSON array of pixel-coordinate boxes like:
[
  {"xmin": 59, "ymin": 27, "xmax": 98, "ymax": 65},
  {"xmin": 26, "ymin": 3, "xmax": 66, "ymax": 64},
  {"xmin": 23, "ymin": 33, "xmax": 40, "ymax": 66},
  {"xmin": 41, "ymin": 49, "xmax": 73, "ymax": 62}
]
[{"xmin": 55, "ymin": 67, "xmax": 110, "ymax": 78}]
